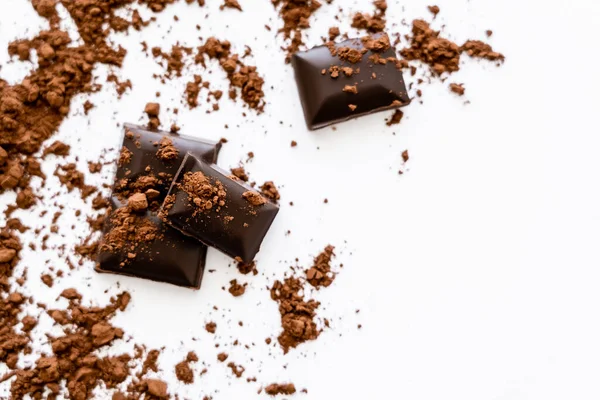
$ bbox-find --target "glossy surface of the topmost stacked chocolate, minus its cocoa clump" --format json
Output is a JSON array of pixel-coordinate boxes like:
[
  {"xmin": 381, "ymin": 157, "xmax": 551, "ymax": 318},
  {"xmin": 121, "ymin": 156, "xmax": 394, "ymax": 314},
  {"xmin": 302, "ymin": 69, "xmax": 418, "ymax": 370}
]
[{"xmin": 161, "ymin": 154, "xmax": 279, "ymax": 263}]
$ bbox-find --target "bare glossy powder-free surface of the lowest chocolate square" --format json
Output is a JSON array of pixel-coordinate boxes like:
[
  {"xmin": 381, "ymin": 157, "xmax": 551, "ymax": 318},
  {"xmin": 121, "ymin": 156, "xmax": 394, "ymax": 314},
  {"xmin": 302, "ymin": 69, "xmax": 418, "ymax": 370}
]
[{"xmin": 96, "ymin": 198, "xmax": 207, "ymax": 289}]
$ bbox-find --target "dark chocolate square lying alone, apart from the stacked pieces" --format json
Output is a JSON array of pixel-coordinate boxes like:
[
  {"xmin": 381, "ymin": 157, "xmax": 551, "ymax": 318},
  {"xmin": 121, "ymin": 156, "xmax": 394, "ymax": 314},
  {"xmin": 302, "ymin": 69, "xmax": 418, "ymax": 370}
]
[{"xmin": 292, "ymin": 34, "xmax": 410, "ymax": 130}]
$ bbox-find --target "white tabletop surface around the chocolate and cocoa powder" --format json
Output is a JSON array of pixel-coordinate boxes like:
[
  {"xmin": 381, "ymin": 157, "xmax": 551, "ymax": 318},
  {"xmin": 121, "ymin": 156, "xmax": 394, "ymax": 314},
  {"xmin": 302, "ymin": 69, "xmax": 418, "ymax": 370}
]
[{"xmin": 0, "ymin": 0, "xmax": 600, "ymax": 400}]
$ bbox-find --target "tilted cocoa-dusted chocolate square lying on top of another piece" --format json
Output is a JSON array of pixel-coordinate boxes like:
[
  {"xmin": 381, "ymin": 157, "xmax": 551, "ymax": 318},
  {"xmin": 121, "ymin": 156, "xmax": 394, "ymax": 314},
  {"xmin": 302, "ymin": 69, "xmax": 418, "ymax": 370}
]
[{"xmin": 159, "ymin": 154, "xmax": 279, "ymax": 263}]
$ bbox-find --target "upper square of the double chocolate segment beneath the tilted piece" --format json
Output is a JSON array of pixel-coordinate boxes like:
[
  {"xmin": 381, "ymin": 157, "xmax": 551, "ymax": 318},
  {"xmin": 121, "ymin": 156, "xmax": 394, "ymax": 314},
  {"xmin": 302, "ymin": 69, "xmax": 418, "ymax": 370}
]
[{"xmin": 113, "ymin": 124, "xmax": 221, "ymax": 206}]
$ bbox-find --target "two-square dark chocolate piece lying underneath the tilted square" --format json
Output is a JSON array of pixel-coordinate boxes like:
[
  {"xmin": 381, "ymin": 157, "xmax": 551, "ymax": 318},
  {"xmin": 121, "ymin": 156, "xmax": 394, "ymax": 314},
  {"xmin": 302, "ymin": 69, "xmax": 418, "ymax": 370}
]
[{"xmin": 96, "ymin": 124, "xmax": 221, "ymax": 289}]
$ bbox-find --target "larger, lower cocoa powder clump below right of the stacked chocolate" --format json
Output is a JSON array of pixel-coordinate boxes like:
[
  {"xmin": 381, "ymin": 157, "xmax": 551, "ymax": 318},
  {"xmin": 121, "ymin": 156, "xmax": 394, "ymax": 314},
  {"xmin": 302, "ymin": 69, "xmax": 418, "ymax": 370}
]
[{"xmin": 271, "ymin": 277, "xmax": 321, "ymax": 353}]
